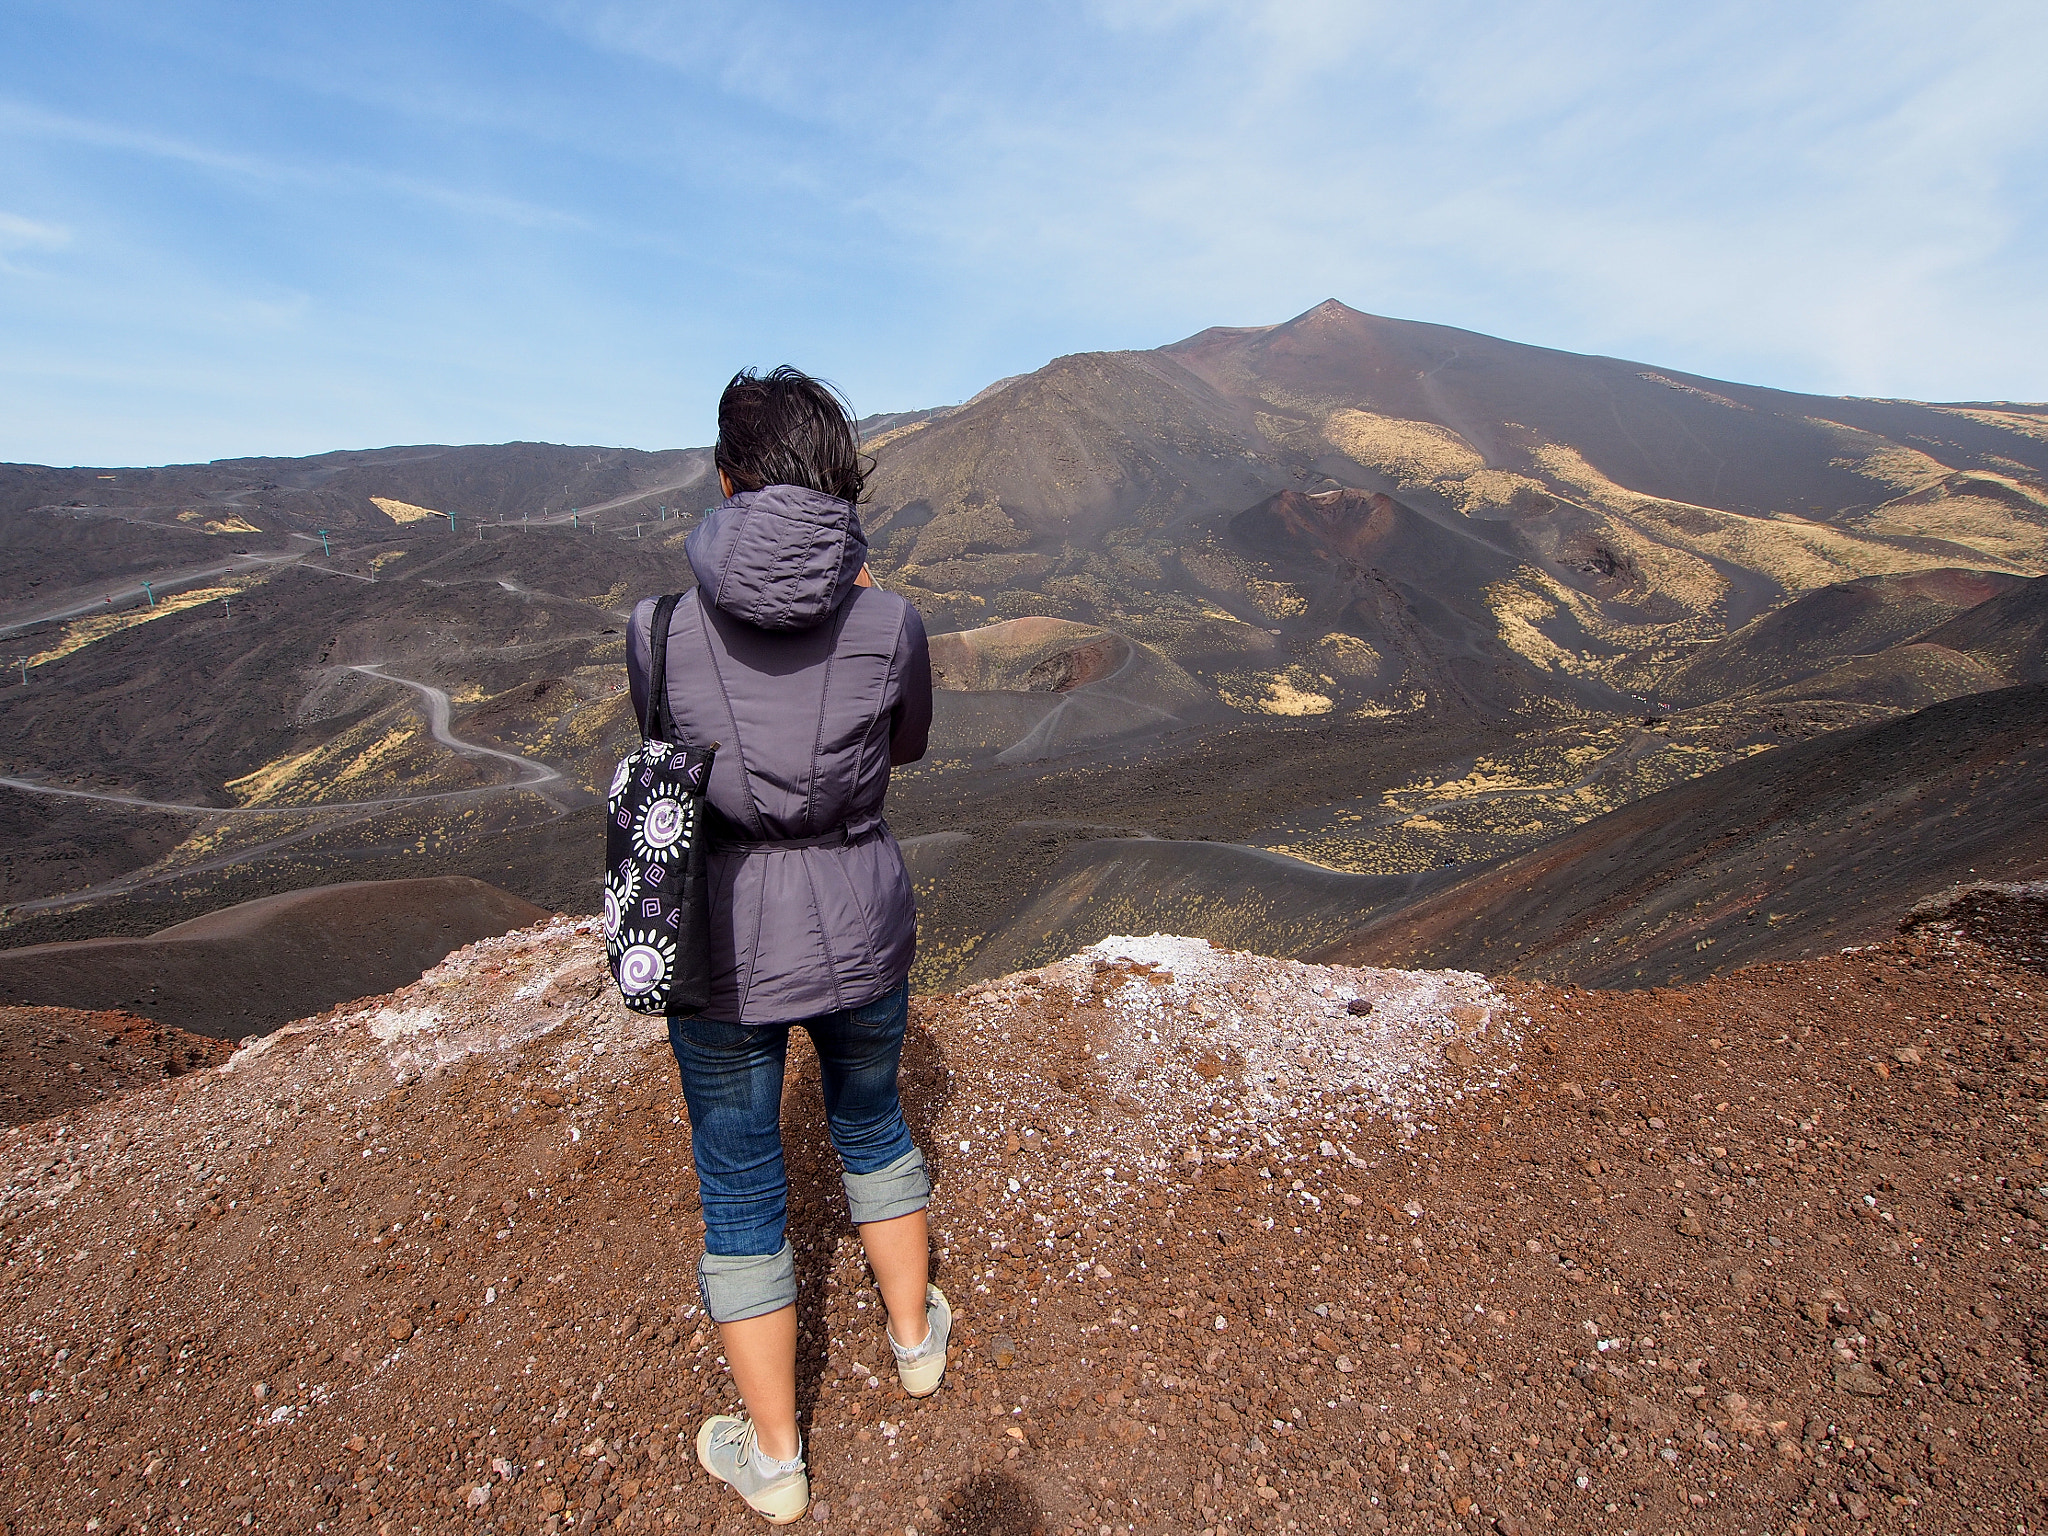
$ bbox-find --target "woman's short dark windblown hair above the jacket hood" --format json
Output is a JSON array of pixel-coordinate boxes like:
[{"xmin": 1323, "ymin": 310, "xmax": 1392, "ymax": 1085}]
[{"xmin": 713, "ymin": 362, "xmax": 874, "ymax": 502}]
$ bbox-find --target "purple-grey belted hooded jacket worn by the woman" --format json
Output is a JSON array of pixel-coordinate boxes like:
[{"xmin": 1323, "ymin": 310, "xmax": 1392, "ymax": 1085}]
[{"xmin": 627, "ymin": 485, "xmax": 932, "ymax": 1024}]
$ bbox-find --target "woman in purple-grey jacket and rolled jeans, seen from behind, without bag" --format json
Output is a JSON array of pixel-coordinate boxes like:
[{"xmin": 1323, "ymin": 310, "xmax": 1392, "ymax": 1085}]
[{"xmin": 627, "ymin": 369, "xmax": 952, "ymax": 1524}]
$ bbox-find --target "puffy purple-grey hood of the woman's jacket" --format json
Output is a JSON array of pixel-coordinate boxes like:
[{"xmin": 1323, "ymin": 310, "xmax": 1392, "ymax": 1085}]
[{"xmin": 684, "ymin": 485, "xmax": 868, "ymax": 629}]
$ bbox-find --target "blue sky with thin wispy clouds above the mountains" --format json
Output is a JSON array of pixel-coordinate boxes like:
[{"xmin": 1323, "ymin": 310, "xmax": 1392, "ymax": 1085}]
[{"xmin": 0, "ymin": 0, "xmax": 2048, "ymax": 465}]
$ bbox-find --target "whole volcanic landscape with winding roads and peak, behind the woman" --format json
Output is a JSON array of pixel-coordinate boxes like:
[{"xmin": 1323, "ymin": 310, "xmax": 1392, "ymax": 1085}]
[{"xmin": 0, "ymin": 303, "xmax": 2048, "ymax": 1001}]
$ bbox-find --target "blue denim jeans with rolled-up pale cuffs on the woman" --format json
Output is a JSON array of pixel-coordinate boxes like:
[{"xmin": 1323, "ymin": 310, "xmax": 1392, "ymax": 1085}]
[{"xmin": 668, "ymin": 981, "xmax": 932, "ymax": 1323}]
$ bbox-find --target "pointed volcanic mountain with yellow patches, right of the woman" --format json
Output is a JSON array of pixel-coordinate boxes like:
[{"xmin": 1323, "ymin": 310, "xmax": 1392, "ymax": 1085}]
[{"xmin": 851, "ymin": 301, "xmax": 2048, "ymax": 713}]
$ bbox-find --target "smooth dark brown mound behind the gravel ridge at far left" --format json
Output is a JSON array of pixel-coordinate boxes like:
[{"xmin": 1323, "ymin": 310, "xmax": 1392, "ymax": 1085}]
[{"xmin": 0, "ymin": 874, "xmax": 547, "ymax": 1040}]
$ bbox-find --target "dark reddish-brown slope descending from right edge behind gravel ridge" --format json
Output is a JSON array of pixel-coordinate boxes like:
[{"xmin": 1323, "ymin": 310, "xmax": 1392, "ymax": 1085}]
[{"xmin": 1317, "ymin": 684, "xmax": 2048, "ymax": 985}]
